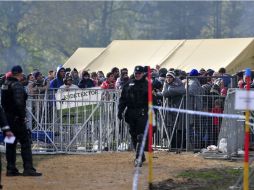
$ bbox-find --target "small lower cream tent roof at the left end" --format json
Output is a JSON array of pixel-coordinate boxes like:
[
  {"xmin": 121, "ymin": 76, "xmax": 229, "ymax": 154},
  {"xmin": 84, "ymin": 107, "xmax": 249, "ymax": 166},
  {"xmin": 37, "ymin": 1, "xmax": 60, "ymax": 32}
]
[{"xmin": 63, "ymin": 48, "xmax": 105, "ymax": 72}]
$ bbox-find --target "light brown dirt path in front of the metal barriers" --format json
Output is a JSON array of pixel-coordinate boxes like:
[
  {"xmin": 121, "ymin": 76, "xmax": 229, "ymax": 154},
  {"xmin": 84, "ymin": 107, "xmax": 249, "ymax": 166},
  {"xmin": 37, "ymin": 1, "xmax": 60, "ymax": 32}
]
[{"xmin": 2, "ymin": 152, "xmax": 248, "ymax": 190}]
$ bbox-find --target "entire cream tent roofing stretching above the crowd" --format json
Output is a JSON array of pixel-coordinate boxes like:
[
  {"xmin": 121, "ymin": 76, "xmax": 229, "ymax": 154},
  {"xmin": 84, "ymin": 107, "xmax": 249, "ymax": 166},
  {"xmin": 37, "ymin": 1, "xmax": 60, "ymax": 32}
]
[{"xmin": 69, "ymin": 38, "xmax": 254, "ymax": 74}]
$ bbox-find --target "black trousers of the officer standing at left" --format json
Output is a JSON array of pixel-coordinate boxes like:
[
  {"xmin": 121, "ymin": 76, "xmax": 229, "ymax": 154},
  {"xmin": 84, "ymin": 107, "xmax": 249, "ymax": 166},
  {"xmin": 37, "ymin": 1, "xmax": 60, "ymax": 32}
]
[{"xmin": 6, "ymin": 120, "xmax": 33, "ymax": 170}]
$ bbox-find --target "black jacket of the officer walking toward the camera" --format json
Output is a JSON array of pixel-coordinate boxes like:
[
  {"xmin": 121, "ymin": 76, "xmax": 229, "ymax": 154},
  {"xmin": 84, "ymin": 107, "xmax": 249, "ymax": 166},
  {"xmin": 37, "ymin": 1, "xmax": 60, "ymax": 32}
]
[{"xmin": 118, "ymin": 78, "xmax": 148, "ymax": 113}]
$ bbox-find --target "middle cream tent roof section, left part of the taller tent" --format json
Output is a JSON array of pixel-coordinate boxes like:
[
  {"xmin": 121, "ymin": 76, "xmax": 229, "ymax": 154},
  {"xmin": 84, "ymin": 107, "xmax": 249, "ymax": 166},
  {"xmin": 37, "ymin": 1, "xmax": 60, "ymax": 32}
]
[{"xmin": 86, "ymin": 40, "xmax": 182, "ymax": 72}]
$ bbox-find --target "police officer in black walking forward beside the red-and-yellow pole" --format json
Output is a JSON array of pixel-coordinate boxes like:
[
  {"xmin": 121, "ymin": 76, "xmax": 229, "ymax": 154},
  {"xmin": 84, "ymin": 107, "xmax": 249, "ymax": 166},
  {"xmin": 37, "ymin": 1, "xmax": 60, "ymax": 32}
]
[{"xmin": 118, "ymin": 66, "xmax": 148, "ymax": 167}]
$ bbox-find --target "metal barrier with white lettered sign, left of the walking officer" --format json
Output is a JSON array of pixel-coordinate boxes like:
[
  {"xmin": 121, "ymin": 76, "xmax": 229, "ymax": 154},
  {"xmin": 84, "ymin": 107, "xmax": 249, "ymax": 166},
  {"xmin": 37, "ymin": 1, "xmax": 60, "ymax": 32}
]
[{"xmin": 27, "ymin": 89, "xmax": 130, "ymax": 153}]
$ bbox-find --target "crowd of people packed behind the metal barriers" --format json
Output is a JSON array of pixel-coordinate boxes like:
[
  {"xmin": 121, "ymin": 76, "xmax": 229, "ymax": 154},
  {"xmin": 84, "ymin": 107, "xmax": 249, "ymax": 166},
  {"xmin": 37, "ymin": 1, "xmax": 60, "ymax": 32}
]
[{"xmin": 1, "ymin": 65, "xmax": 254, "ymax": 96}]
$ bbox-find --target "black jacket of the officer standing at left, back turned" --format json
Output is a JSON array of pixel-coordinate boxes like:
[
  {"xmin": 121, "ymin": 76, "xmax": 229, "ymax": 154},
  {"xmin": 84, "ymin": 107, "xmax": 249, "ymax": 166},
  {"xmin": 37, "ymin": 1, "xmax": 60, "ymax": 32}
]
[{"xmin": 1, "ymin": 77, "xmax": 27, "ymax": 121}]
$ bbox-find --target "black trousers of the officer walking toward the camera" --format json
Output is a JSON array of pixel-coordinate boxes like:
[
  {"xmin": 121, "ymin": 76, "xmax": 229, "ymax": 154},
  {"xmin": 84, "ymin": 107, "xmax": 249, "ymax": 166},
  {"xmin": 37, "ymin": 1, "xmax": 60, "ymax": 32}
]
[{"xmin": 125, "ymin": 109, "xmax": 148, "ymax": 158}]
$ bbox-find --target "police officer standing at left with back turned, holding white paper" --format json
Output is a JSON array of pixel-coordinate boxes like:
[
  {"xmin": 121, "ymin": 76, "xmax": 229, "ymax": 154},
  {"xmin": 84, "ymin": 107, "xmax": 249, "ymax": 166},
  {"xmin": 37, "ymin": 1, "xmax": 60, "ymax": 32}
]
[{"xmin": 1, "ymin": 65, "xmax": 42, "ymax": 176}]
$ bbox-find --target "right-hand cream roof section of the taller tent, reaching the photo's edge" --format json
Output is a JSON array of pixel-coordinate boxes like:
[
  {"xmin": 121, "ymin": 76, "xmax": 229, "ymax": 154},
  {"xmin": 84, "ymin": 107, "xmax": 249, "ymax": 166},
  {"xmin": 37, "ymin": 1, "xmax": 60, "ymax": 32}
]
[{"xmin": 161, "ymin": 38, "xmax": 254, "ymax": 73}]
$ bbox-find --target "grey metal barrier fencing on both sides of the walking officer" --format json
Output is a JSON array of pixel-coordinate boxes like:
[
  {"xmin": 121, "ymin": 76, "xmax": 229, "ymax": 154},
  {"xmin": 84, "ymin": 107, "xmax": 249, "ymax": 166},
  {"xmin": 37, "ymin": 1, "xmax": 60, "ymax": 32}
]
[{"xmin": 27, "ymin": 89, "xmax": 254, "ymax": 153}]
